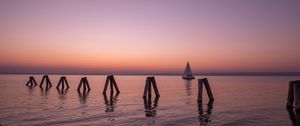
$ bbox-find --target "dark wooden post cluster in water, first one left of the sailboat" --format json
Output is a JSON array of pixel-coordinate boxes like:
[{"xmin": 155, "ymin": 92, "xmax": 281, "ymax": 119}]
[{"xmin": 143, "ymin": 77, "xmax": 160, "ymax": 98}]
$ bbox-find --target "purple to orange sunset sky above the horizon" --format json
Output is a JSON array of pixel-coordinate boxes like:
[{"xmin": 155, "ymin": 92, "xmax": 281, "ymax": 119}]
[{"xmin": 0, "ymin": 0, "xmax": 300, "ymax": 74}]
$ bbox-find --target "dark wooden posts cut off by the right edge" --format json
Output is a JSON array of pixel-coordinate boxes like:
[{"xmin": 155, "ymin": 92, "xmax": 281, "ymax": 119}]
[{"xmin": 286, "ymin": 80, "xmax": 300, "ymax": 111}]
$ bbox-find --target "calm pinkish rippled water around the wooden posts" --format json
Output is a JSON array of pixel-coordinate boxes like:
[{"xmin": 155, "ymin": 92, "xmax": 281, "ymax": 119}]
[{"xmin": 0, "ymin": 75, "xmax": 300, "ymax": 126}]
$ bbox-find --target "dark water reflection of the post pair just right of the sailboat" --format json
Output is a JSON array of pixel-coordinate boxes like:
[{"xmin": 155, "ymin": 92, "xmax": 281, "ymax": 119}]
[{"xmin": 198, "ymin": 100, "xmax": 214, "ymax": 125}]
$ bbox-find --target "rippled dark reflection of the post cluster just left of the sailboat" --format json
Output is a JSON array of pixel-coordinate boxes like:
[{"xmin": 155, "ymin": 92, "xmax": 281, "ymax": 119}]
[{"xmin": 143, "ymin": 97, "xmax": 159, "ymax": 117}]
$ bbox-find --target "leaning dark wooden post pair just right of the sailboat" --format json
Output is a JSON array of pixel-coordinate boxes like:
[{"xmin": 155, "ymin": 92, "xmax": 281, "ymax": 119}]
[{"xmin": 198, "ymin": 78, "xmax": 214, "ymax": 102}]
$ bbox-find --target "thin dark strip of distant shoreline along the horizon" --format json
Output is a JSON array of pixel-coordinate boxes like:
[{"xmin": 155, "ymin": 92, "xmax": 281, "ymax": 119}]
[{"xmin": 0, "ymin": 72, "xmax": 300, "ymax": 76}]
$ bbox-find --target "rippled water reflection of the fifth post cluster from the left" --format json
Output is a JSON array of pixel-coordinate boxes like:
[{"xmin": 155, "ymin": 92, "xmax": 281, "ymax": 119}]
[{"xmin": 103, "ymin": 93, "xmax": 120, "ymax": 112}]
